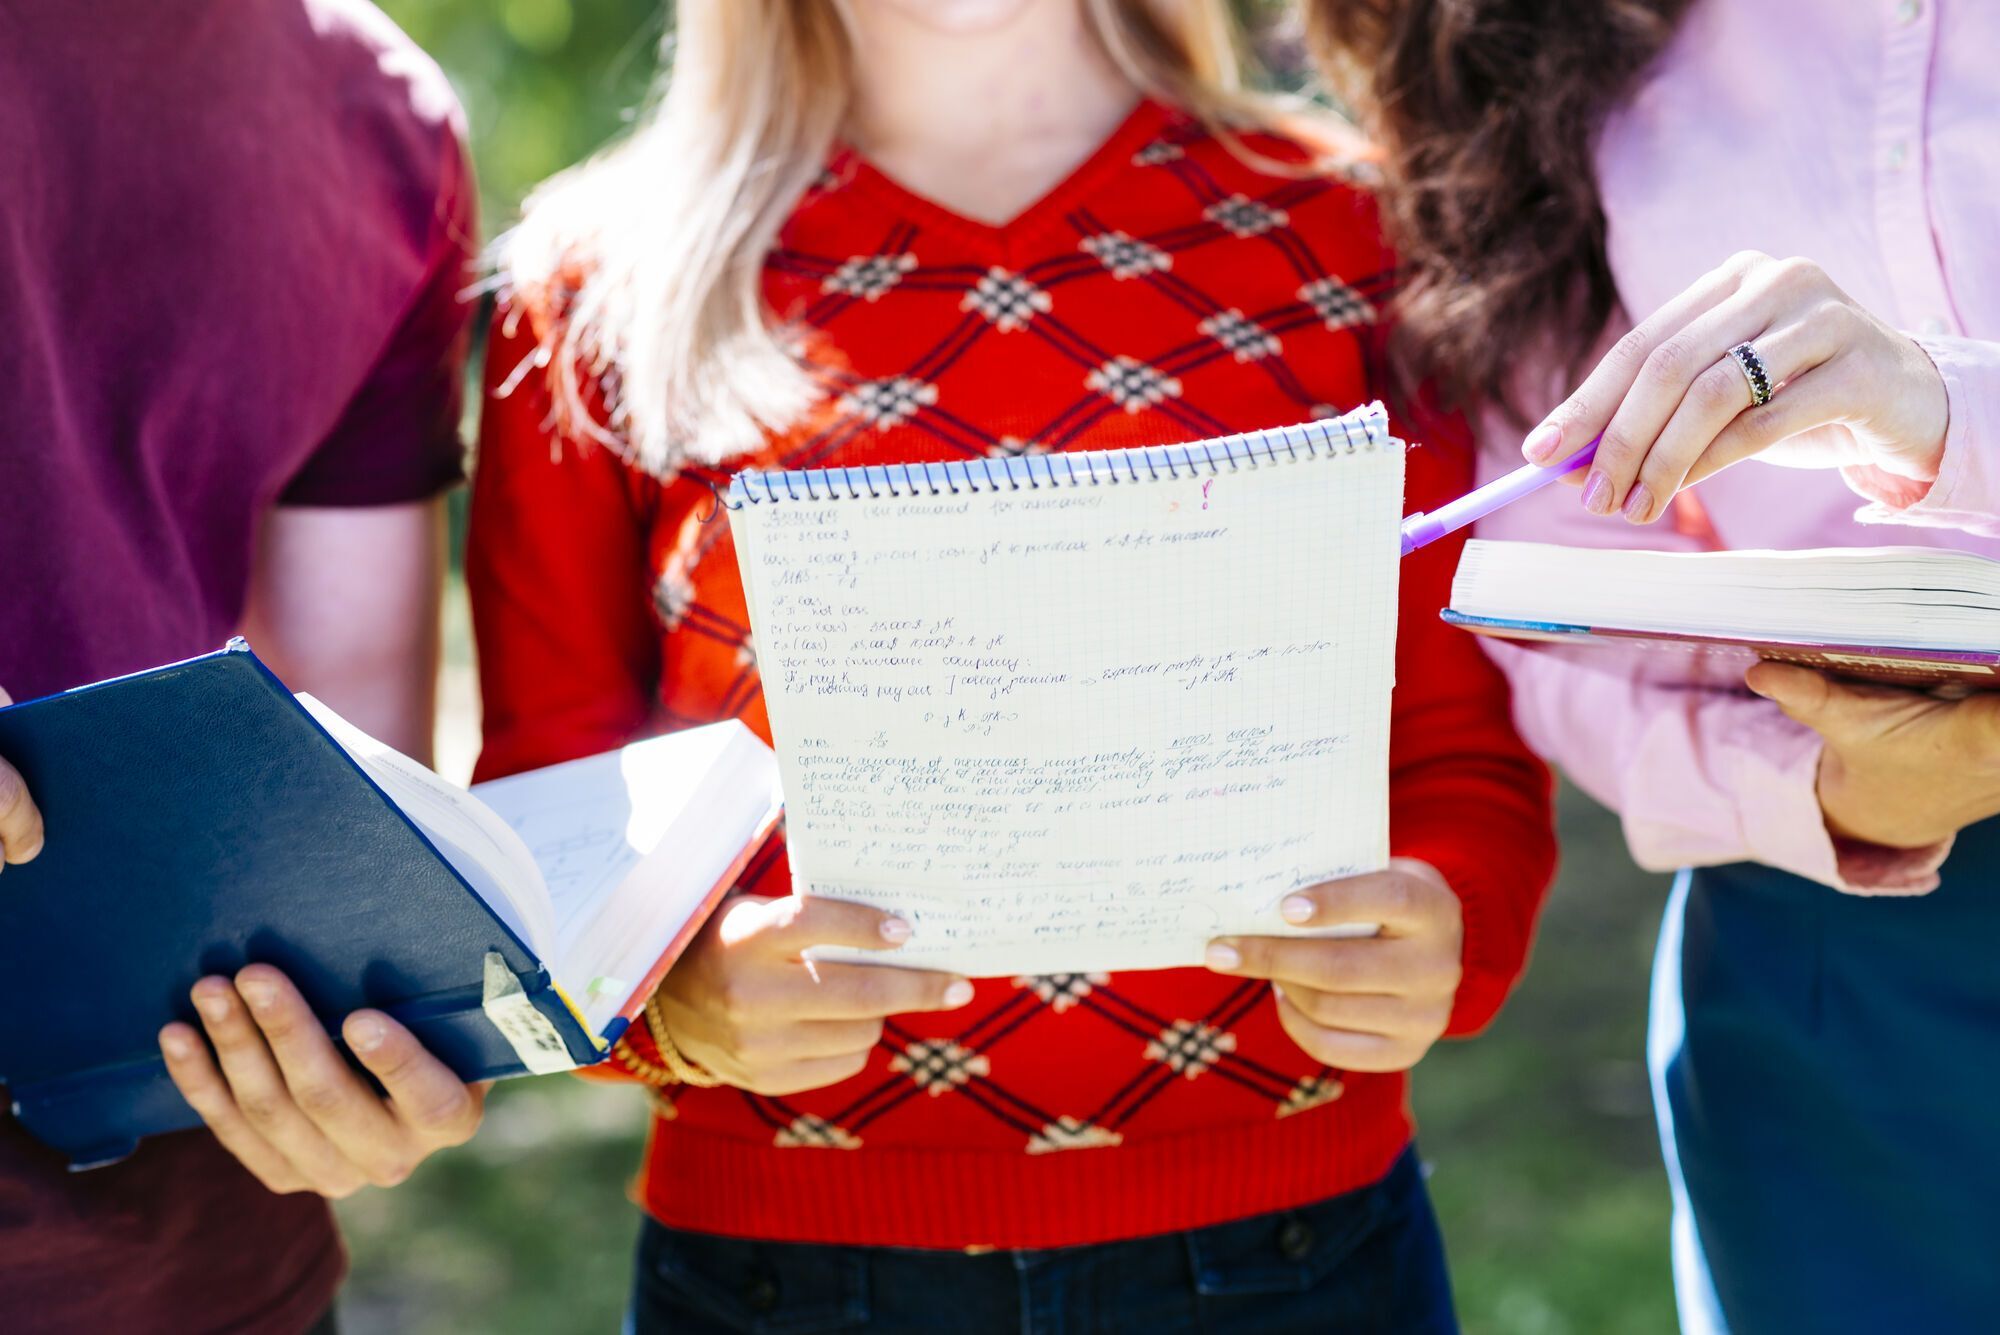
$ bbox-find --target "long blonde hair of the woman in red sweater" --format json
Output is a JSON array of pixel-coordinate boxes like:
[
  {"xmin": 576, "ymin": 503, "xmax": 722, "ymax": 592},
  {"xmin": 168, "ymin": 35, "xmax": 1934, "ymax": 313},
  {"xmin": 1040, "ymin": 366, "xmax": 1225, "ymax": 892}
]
[{"xmin": 496, "ymin": 0, "xmax": 1268, "ymax": 476}]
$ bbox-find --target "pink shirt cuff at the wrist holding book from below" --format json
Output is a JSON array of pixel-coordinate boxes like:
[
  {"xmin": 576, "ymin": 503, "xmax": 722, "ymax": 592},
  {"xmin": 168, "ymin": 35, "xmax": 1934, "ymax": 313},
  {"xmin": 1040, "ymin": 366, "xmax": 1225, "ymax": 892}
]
[{"xmin": 1738, "ymin": 707, "xmax": 1952, "ymax": 895}]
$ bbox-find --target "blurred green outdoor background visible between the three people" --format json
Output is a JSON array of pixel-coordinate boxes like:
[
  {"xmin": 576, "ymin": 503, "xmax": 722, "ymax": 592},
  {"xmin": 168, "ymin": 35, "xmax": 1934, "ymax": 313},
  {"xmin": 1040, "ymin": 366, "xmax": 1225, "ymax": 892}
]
[{"xmin": 340, "ymin": 0, "xmax": 1674, "ymax": 1335}]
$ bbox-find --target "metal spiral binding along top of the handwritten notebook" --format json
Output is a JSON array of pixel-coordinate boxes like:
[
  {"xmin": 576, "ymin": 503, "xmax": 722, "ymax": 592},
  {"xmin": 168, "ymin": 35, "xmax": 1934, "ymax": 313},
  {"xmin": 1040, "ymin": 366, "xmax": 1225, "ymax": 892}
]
[{"xmin": 722, "ymin": 404, "xmax": 1396, "ymax": 510}]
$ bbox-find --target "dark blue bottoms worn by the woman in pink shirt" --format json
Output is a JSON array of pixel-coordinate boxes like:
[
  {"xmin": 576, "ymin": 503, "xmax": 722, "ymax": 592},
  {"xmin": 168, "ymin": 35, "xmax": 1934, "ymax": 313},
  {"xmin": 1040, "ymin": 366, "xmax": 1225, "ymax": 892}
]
[{"xmin": 1648, "ymin": 819, "xmax": 2000, "ymax": 1335}]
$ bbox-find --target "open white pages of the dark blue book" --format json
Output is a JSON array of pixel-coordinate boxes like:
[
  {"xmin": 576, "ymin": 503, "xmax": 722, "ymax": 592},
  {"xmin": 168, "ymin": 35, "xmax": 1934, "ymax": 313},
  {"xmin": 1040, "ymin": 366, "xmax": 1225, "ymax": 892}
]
[{"xmin": 298, "ymin": 695, "xmax": 778, "ymax": 1033}]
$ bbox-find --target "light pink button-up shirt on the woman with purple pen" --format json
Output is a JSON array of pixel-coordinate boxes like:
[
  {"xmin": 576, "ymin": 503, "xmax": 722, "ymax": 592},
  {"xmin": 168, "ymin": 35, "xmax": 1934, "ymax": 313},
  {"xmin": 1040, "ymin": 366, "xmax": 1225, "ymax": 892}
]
[{"xmin": 1480, "ymin": 0, "xmax": 2000, "ymax": 891}]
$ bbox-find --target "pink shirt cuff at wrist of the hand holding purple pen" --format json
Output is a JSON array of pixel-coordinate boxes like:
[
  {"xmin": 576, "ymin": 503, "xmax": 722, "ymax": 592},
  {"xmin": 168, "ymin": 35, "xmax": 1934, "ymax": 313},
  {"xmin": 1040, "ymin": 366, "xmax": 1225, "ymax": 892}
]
[{"xmin": 1840, "ymin": 336, "xmax": 2000, "ymax": 534}]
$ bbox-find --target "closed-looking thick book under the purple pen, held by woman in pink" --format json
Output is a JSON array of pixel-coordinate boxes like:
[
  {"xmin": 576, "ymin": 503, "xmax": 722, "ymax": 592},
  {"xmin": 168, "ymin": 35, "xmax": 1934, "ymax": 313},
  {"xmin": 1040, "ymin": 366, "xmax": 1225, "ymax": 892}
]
[{"xmin": 1444, "ymin": 540, "xmax": 2000, "ymax": 689}]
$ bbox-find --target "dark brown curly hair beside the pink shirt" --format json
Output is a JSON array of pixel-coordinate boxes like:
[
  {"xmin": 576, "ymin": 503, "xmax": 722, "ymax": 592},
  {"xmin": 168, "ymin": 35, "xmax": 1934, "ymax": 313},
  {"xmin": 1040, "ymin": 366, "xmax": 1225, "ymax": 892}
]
[{"xmin": 1304, "ymin": 0, "xmax": 1692, "ymax": 416}]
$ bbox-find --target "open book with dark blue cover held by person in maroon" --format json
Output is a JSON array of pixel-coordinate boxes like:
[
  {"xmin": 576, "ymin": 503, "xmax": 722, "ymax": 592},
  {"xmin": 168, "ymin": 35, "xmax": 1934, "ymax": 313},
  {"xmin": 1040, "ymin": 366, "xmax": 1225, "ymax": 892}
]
[{"xmin": 0, "ymin": 642, "xmax": 778, "ymax": 1165}]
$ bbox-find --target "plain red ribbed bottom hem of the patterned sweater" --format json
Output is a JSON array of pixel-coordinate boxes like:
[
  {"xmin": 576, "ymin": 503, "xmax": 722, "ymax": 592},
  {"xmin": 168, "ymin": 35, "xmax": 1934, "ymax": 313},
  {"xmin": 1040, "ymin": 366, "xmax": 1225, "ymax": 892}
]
[{"xmin": 638, "ymin": 1075, "xmax": 1412, "ymax": 1249}]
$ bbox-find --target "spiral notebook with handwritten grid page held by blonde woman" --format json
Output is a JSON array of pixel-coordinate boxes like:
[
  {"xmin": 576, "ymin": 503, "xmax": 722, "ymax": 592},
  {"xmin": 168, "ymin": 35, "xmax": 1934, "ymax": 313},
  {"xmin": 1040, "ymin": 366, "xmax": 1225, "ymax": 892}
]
[{"xmin": 724, "ymin": 404, "xmax": 1402, "ymax": 977}]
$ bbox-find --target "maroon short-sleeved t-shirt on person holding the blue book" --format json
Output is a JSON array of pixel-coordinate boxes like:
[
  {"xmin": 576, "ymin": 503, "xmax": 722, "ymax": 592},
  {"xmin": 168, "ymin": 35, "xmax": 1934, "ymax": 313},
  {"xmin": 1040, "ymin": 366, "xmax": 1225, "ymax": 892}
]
[{"xmin": 0, "ymin": 0, "xmax": 472, "ymax": 1335}]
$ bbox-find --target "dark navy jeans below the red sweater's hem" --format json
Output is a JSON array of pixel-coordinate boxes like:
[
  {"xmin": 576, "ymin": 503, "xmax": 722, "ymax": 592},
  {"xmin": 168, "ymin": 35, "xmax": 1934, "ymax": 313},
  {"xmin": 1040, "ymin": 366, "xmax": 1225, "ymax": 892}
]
[{"xmin": 630, "ymin": 1147, "xmax": 1458, "ymax": 1335}]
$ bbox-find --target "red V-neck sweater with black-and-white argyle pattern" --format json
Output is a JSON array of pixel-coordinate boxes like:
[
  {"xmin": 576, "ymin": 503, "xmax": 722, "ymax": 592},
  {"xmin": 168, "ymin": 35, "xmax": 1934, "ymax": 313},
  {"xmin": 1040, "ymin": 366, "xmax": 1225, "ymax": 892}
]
[{"xmin": 468, "ymin": 104, "xmax": 1554, "ymax": 1247}]
